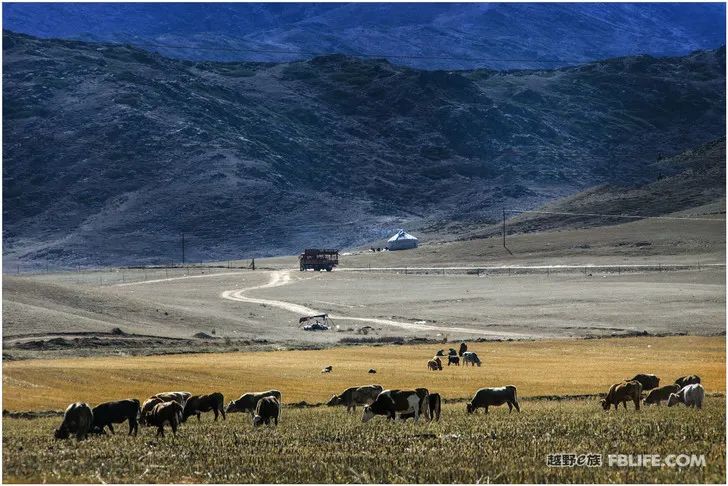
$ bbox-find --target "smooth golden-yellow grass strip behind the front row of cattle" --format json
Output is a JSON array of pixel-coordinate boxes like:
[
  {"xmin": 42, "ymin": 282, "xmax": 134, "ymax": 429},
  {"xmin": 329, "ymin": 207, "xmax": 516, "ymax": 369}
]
[{"xmin": 3, "ymin": 336, "xmax": 726, "ymax": 410}]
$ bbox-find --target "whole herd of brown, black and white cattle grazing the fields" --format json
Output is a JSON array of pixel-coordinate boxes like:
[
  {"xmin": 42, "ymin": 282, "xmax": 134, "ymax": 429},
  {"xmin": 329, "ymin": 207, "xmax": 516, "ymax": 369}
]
[{"xmin": 55, "ymin": 343, "xmax": 705, "ymax": 440}]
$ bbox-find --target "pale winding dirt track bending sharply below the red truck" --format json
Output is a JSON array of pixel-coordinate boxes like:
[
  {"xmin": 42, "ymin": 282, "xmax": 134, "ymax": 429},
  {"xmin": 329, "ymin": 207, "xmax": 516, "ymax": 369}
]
[{"xmin": 221, "ymin": 270, "xmax": 529, "ymax": 338}]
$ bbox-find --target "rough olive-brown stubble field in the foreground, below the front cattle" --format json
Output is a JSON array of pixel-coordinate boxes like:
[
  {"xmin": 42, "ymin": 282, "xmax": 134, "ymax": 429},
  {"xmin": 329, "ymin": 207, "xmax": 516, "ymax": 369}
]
[{"xmin": 2, "ymin": 397, "xmax": 725, "ymax": 484}]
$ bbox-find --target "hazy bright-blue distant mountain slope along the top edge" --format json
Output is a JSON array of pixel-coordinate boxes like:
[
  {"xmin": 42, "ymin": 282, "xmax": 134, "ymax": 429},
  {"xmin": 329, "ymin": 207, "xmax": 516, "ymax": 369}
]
[{"xmin": 3, "ymin": 3, "xmax": 725, "ymax": 69}]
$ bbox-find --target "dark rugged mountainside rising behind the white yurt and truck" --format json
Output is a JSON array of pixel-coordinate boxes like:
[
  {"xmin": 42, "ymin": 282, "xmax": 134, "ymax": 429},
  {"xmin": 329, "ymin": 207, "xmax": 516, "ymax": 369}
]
[{"xmin": 3, "ymin": 31, "xmax": 726, "ymax": 265}]
